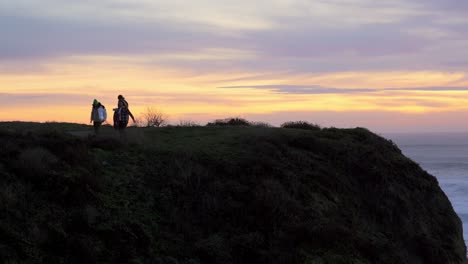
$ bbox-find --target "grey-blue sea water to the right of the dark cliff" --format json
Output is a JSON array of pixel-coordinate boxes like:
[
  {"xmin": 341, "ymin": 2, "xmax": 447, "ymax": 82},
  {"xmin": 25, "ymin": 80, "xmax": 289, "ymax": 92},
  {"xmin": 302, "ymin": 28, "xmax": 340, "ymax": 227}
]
[{"xmin": 383, "ymin": 133, "xmax": 468, "ymax": 245}]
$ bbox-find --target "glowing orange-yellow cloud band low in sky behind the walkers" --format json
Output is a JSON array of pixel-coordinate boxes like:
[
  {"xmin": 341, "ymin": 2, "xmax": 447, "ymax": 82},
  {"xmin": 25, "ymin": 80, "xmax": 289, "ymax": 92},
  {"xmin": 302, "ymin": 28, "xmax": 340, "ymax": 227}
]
[{"xmin": 0, "ymin": 56, "xmax": 468, "ymax": 128}]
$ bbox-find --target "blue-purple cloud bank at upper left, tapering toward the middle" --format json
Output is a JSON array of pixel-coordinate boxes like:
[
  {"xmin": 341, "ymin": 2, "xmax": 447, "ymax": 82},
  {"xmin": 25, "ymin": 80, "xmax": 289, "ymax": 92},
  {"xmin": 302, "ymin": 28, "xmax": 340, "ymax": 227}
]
[{"xmin": 0, "ymin": 13, "xmax": 239, "ymax": 60}]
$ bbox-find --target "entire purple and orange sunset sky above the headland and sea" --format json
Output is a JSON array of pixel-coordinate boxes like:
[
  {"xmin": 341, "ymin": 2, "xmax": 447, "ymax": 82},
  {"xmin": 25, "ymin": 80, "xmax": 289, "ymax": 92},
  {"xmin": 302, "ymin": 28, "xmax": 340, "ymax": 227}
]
[{"xmin": 0, "ymin": 0, "xmax": 468, "ymax": 132}]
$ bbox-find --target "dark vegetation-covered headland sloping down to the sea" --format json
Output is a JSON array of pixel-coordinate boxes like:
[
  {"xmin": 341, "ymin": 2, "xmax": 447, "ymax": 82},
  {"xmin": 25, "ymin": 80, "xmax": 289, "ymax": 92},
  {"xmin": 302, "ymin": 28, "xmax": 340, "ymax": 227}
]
[{"xmin": 0, "ymin": 122, "xmax": 466, "ymax": 264}]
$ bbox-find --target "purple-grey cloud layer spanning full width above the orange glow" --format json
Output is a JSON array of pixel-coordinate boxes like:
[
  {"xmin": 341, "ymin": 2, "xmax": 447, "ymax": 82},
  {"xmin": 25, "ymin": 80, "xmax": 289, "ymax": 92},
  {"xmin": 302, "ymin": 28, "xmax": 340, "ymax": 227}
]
[{"xmin": 0, "ymin": 0, "xmax": 468, "ymax": 74}]
